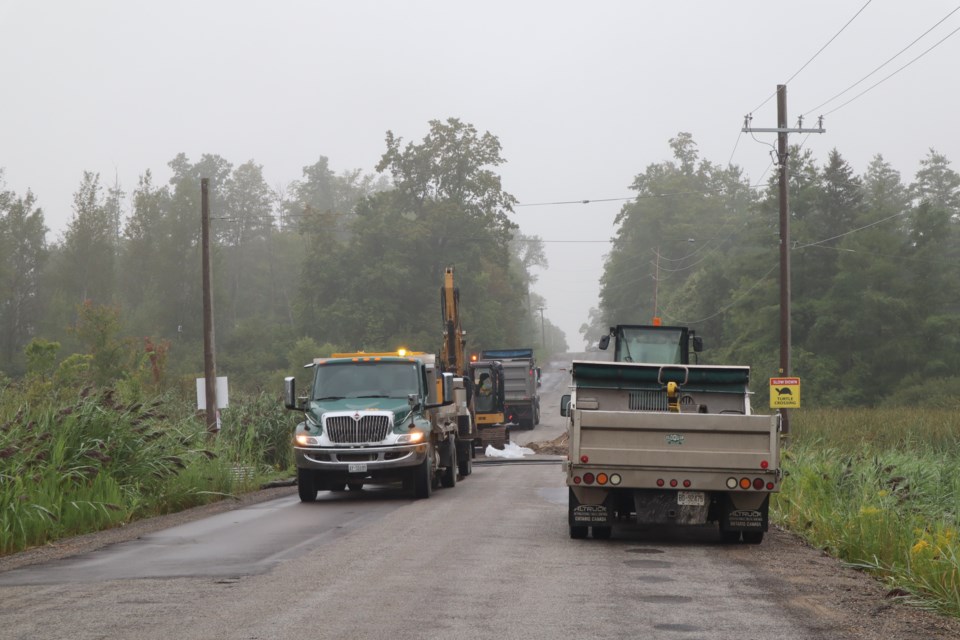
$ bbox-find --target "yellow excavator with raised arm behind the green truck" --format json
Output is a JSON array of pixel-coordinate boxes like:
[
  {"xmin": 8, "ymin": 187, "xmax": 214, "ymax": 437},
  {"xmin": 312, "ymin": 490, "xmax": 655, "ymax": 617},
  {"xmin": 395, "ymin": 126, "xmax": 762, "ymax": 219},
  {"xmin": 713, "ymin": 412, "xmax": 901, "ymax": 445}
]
[{"xmin": 440, "ymin": 267, "xmax": 510, "ymax": 452}]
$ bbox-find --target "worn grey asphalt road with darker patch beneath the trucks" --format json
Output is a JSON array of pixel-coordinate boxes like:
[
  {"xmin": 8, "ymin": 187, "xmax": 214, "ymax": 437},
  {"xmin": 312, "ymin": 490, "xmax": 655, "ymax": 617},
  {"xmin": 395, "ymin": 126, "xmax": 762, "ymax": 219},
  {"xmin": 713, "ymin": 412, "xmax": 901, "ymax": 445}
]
[{"xmin": 0, "ymin": 352, "xmax": 952, "ymax": 640}]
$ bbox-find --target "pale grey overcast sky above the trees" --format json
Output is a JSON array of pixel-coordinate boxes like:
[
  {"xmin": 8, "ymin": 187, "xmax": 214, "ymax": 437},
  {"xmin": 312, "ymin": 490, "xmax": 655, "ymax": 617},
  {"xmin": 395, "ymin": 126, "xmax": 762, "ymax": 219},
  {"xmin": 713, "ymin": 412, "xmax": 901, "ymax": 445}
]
[{"xmin": 0, "ymin": 0, "xmax": 960, "ymax": 349}]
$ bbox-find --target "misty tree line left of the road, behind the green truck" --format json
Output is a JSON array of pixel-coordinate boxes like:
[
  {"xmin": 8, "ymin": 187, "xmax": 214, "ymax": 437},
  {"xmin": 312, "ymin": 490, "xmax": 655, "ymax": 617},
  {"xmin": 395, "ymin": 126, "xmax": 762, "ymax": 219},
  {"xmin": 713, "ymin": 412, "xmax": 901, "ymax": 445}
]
[{"xmin": 0, "ymin": 118, "xmax": 566, "ymax": 390}]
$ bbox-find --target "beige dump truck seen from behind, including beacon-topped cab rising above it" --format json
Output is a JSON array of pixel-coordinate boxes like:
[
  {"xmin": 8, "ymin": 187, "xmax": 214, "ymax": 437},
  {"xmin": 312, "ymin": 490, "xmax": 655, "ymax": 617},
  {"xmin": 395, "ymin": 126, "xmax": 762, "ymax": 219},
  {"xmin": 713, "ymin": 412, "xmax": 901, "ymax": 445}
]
[{"xmin": 560, "ymin": 325, "xmax": 781, "ymax": 543}]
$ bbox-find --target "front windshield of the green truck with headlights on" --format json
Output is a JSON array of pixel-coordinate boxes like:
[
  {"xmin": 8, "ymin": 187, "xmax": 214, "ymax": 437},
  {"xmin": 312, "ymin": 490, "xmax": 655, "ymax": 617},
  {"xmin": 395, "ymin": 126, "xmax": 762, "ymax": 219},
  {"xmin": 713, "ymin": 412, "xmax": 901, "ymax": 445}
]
[{"xmin": 313, "ymin": 362, "xmax": 419, "ymax": 400}]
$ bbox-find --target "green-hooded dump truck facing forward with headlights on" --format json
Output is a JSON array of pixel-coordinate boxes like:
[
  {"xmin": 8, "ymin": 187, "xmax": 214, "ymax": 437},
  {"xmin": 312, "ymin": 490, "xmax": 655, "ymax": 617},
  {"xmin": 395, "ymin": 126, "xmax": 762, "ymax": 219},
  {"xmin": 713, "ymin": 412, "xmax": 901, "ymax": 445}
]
[{"xmin": 284, "ymin": 349, "xmax": 463, "ymax": 502}]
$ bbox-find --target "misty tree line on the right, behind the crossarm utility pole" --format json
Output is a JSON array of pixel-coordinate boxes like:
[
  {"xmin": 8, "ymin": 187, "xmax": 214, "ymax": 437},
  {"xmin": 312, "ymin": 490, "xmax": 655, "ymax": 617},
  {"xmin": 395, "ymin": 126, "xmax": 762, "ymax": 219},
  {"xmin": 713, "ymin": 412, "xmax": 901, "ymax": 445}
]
[{"xmin": 581, "ymin": 133, "xmax": 960, "ymax": 407}]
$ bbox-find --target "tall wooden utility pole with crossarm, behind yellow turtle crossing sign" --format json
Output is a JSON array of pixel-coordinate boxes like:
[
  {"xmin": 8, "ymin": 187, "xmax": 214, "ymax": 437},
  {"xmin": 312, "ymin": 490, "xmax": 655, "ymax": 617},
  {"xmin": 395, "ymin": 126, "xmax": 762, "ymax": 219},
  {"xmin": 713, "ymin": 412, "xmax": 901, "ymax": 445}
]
[{"xmin": 743, "ymin": 84, "xmax": 826, "ymax": 436}]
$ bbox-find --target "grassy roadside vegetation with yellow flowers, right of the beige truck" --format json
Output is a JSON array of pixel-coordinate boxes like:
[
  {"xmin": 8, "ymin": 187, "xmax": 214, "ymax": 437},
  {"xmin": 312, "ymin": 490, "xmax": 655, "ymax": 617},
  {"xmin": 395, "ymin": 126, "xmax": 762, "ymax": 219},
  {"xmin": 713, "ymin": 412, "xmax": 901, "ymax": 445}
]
[{"xmin": 773, "ymin": 408, "xmax": 960, "ymax": 617}]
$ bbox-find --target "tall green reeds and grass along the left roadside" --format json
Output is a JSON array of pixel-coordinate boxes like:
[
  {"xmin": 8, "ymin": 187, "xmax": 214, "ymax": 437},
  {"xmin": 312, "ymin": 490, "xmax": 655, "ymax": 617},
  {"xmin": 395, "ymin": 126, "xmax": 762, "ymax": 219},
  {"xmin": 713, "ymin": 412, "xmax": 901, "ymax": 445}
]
[{"xmin": 0, "ymin": 386, "xmax": 291, "ymax": 554}]
